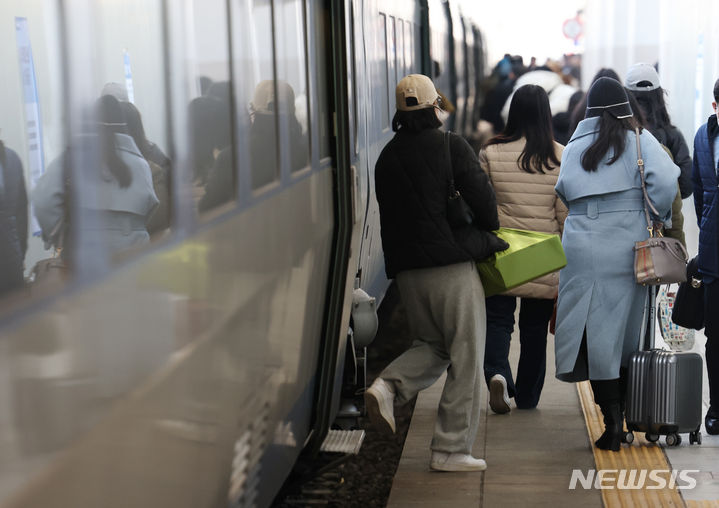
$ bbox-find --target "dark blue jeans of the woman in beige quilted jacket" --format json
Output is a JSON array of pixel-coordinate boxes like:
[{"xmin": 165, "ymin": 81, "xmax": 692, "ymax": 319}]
[{"xmin": 484, "ymin": 295, "xmax": 554, "ymax": 409}]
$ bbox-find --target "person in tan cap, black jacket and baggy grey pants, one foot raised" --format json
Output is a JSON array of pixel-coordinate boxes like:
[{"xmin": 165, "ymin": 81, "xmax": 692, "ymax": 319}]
[{"xmin": 365, "ymin": 74, "xmax": 508, "ymax": 471}]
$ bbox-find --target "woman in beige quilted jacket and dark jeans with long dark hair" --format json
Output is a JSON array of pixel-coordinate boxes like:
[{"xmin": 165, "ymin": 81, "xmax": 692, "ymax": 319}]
[{"xmin": 479, "ymin": 85, "xmax": 567, "ymax": 413}]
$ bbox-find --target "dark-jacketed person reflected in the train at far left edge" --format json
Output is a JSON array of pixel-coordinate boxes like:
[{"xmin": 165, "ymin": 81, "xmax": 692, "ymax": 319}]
[{"xmin": 0, "ymin": 141, "xmax": 27, "ymax": 296}]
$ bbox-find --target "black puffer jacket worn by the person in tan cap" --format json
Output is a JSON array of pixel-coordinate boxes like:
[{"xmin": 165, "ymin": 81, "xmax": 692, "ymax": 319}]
[{"xmin": 375, "ymin": 129, "xmax": 507, "ymax": 278}]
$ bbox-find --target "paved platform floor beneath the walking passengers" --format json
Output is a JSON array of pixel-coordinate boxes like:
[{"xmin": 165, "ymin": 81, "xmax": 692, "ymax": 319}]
[{"xmin": 387, "ymin": 324, "xmax": 719, "ymax": 508}]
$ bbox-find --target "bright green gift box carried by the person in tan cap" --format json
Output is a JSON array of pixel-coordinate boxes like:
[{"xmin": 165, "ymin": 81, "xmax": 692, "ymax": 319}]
[{"xmin": 477, "ymin": 228, "xmax": 567, "ymax": 296}]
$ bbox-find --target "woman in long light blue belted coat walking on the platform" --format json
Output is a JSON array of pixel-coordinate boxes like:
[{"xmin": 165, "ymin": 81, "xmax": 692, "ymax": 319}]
[{"xmin": 555, "ymin": 78, "xmax": 679, "ymax": 451}]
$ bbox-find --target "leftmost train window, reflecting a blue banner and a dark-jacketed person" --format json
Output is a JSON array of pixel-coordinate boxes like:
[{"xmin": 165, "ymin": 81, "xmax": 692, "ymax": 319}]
[{"xmin": 0, "ymin": 0, "xmax": 69, "ymax": 306}]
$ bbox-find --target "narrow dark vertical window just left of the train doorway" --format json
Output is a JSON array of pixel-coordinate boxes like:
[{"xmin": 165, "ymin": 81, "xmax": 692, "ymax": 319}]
[{"xmin": 312, "ymin": 2, "xmax": 334, "ymax": 159}]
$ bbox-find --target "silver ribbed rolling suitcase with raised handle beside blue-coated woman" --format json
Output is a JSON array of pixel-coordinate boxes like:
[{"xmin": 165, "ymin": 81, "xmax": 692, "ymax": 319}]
[{"xmin": 626, "ymin": 288, "xmax": 704, "ymax": 446}]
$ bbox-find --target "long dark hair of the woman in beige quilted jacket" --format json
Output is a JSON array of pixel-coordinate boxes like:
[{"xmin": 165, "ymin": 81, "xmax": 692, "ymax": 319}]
[{"xmin": 486, "ymin": 85, "xmax": 559, "ymax": 173}]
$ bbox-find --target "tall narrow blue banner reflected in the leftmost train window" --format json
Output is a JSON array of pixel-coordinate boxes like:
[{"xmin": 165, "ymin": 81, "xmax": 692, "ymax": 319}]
[{"xmin": 15, "ymin": 17, "xmax": 45, "ymax": 236}]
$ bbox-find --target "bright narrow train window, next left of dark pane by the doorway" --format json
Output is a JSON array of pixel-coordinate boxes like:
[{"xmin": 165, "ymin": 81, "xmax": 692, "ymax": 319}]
[{"xmin": 275, "ymin": 0, "xmax": 309, "ymax": 171}]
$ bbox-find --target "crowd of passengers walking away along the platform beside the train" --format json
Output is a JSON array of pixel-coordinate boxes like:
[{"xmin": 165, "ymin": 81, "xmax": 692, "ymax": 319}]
[{"xmin": 365, "ymin": 60, "xmax": 719, "ymax": 471}]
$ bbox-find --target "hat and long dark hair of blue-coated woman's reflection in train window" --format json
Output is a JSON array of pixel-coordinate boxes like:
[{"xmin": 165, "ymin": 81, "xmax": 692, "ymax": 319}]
[{"xmin": 95, "ymin": 95, "xmax": 132, "ymax": 189}]
